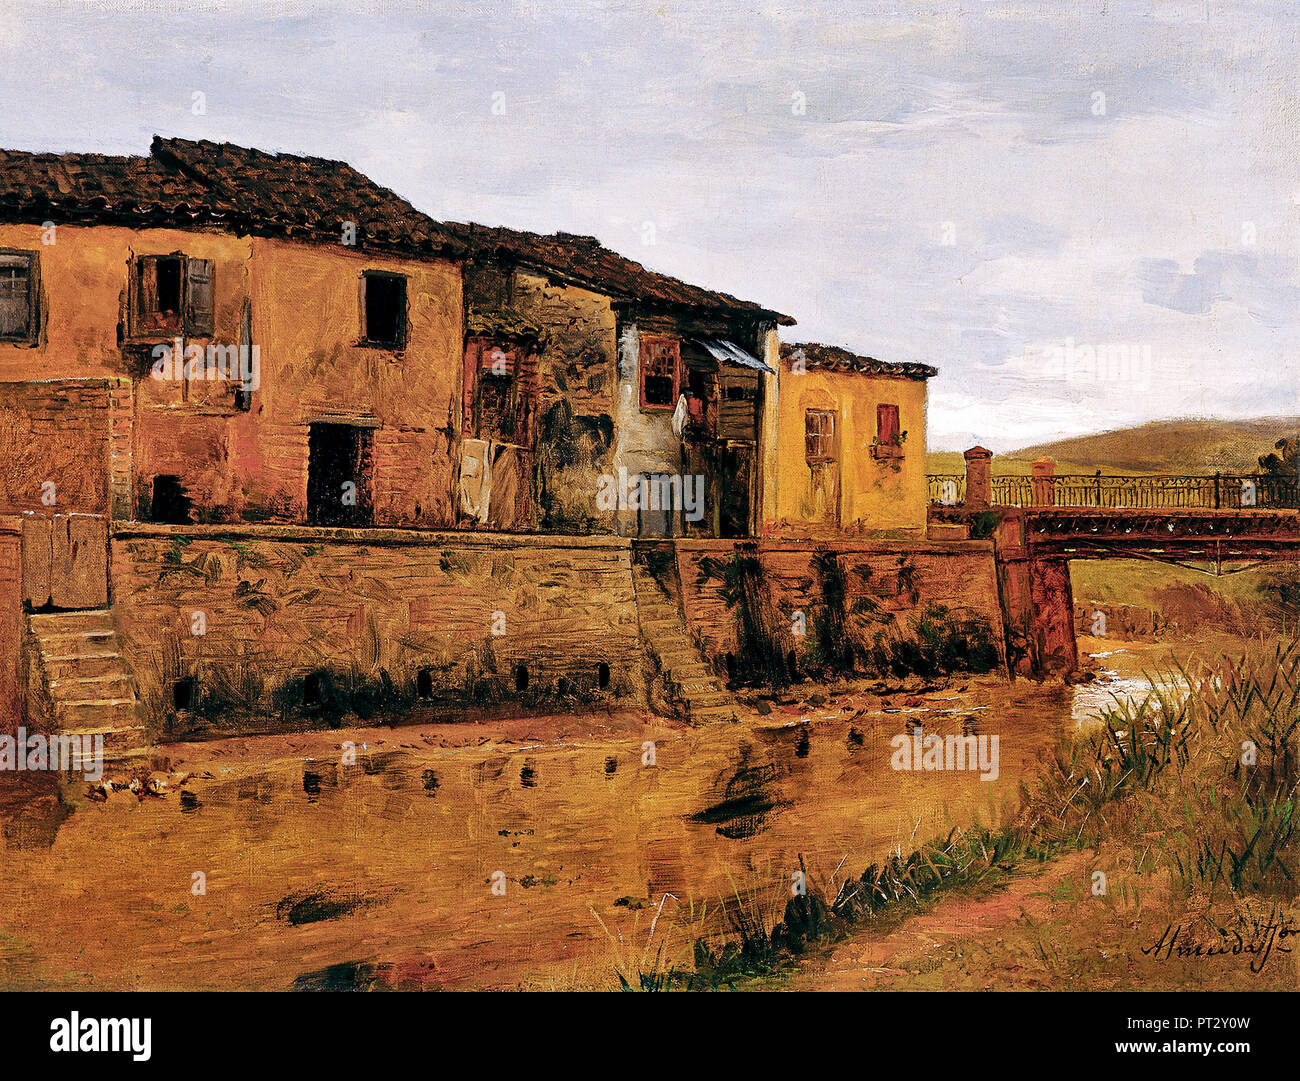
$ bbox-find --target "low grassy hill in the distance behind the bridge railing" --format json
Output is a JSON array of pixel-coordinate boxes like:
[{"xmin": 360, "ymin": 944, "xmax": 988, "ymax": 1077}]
[{"xmin": 926, "ymin": 417, "xmax": 1300, "ymax": 473}]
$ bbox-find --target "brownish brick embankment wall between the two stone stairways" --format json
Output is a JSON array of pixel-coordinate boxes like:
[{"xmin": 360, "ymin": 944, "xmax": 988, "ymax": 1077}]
[{"xmin": 112, "ymin": 525, "xmax": 644, "ymax": 724}]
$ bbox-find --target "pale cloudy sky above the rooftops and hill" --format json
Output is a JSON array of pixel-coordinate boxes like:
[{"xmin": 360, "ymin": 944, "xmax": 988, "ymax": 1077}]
[{"xmin": 0, "ymin": 0, "xmax": 1300, "ymax": 452}]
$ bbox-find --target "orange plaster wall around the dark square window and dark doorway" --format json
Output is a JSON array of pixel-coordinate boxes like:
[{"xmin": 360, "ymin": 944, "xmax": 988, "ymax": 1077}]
[{"xmin": 236, "ymin": 240, "xmax": 462, "ymax": 528}]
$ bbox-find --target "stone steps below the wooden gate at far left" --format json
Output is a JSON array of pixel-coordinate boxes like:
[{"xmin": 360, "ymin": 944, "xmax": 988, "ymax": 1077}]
[{"xmin": 29, "ymin": 608, "xmax": 148, "ymax": 760}]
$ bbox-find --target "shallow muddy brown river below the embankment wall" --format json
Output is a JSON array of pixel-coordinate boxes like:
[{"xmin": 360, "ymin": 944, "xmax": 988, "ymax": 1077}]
[{"xmin": 0, "ymin": 641, "xmax": 1190, "ymax": 989}]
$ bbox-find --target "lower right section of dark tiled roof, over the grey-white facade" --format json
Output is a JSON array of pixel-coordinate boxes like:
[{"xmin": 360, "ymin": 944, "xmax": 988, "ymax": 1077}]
[{"xmin": 449, "ymin": 222, "xmax": 794, "ymax": 326}]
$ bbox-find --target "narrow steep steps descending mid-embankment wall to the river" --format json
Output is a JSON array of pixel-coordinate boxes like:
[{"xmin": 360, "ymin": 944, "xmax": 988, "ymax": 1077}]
[{"xmin": 632, "ymin": 563, "xmax": 737, "ymax": 724}]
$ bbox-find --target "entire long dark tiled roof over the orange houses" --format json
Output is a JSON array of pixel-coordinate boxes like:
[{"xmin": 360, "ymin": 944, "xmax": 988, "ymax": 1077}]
[{"xmin": 0, "ymin": 136, "xmax": 794, "ymax": 325}]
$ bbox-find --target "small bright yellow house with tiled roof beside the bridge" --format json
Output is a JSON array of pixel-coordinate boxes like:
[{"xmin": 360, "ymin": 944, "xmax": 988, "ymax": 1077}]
[{"xmin": 763, "ymin": 343, "xmax": 936, "ymax": 538}]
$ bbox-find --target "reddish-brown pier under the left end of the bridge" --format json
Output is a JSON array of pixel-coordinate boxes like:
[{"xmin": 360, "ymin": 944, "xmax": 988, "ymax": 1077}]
[{"xmin": 993, "ymin": 511, "xmax": 1079, "ymax": 680}]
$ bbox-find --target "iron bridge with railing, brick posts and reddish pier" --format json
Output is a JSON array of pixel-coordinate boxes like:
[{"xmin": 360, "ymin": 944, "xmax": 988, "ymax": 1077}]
[{"xmin": 927, "ymin": 447, "xmax": 1300, "ymax": 677}]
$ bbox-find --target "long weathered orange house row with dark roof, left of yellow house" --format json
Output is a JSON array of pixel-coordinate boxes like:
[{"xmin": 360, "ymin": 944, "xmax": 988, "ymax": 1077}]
[{"xmin": 0, "ymin": 139, "xmax": 792, "ymax": 537}]
